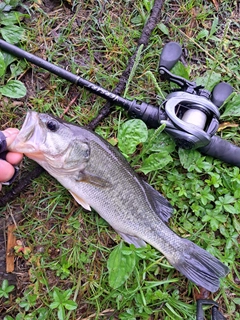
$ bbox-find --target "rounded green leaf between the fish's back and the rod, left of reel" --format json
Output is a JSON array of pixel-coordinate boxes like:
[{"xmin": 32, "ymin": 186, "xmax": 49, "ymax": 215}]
[{"xmin": 118, "ymin": 119, "xmax": 148, "ymax": 155}]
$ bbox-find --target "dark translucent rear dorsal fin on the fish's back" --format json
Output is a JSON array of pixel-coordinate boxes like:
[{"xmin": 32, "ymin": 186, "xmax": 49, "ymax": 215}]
[{"xmin": 143, "ymin": 180, "xmax": 173, "ymax": 223}]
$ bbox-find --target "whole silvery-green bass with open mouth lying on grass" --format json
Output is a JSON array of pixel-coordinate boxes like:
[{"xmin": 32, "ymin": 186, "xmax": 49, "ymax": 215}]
[{"xmin": 9, "ymin": 111, "xmax": 229, "ymax": 292}]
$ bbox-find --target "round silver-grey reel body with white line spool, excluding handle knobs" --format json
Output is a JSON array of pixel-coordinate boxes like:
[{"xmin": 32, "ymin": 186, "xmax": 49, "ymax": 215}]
[{"xmin": 162, "ymin": 91, "xmax": 220, "ymax": 149}]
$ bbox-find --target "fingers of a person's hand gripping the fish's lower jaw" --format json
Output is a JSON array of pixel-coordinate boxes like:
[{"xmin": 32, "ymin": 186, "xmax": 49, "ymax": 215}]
[{"xmin": 0, "ymin": 128, "xmax": 23, "ymax": 190}]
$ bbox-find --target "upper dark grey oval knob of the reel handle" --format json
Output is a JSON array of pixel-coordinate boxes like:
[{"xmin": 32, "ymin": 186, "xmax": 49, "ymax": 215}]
[{"xmin": 160, "ymin": 42, "xmax": 182, "ymax": 70}]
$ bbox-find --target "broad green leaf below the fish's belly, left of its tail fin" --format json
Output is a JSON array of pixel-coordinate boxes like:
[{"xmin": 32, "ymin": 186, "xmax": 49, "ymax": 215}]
[{"xmin": 107, "ymin": 242, "xmax": 136, "ymax": 289}]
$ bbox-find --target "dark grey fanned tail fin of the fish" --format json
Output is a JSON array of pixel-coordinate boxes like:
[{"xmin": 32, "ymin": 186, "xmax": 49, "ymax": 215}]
[{"xmin": 169, "ymin": 239, "xmax": 229, "ymax": 292}]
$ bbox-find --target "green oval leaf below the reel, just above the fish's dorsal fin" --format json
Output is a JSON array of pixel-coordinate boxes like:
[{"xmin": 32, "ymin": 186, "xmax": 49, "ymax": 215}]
[{"xmin": 139, "ymin": 151, "xmax": 173, "ymax": 174}]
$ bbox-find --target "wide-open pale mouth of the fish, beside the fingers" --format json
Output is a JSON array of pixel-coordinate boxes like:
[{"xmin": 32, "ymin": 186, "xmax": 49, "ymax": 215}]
[{"xmin": 9, "ymin": 111, "xmax": 43, "ymax": 154}]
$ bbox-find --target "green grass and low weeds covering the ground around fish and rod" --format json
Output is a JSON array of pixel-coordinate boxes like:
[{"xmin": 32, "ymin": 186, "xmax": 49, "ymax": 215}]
[{"xmin": 0, "ymin": 0, "xmax": 240, "ymax": 320}]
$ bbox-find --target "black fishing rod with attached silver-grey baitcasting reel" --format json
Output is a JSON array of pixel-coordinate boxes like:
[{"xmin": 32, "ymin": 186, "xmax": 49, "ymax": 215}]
[{"xmin": 0, "ymin": 39, "xmax": 240, "ymax": 167}]
